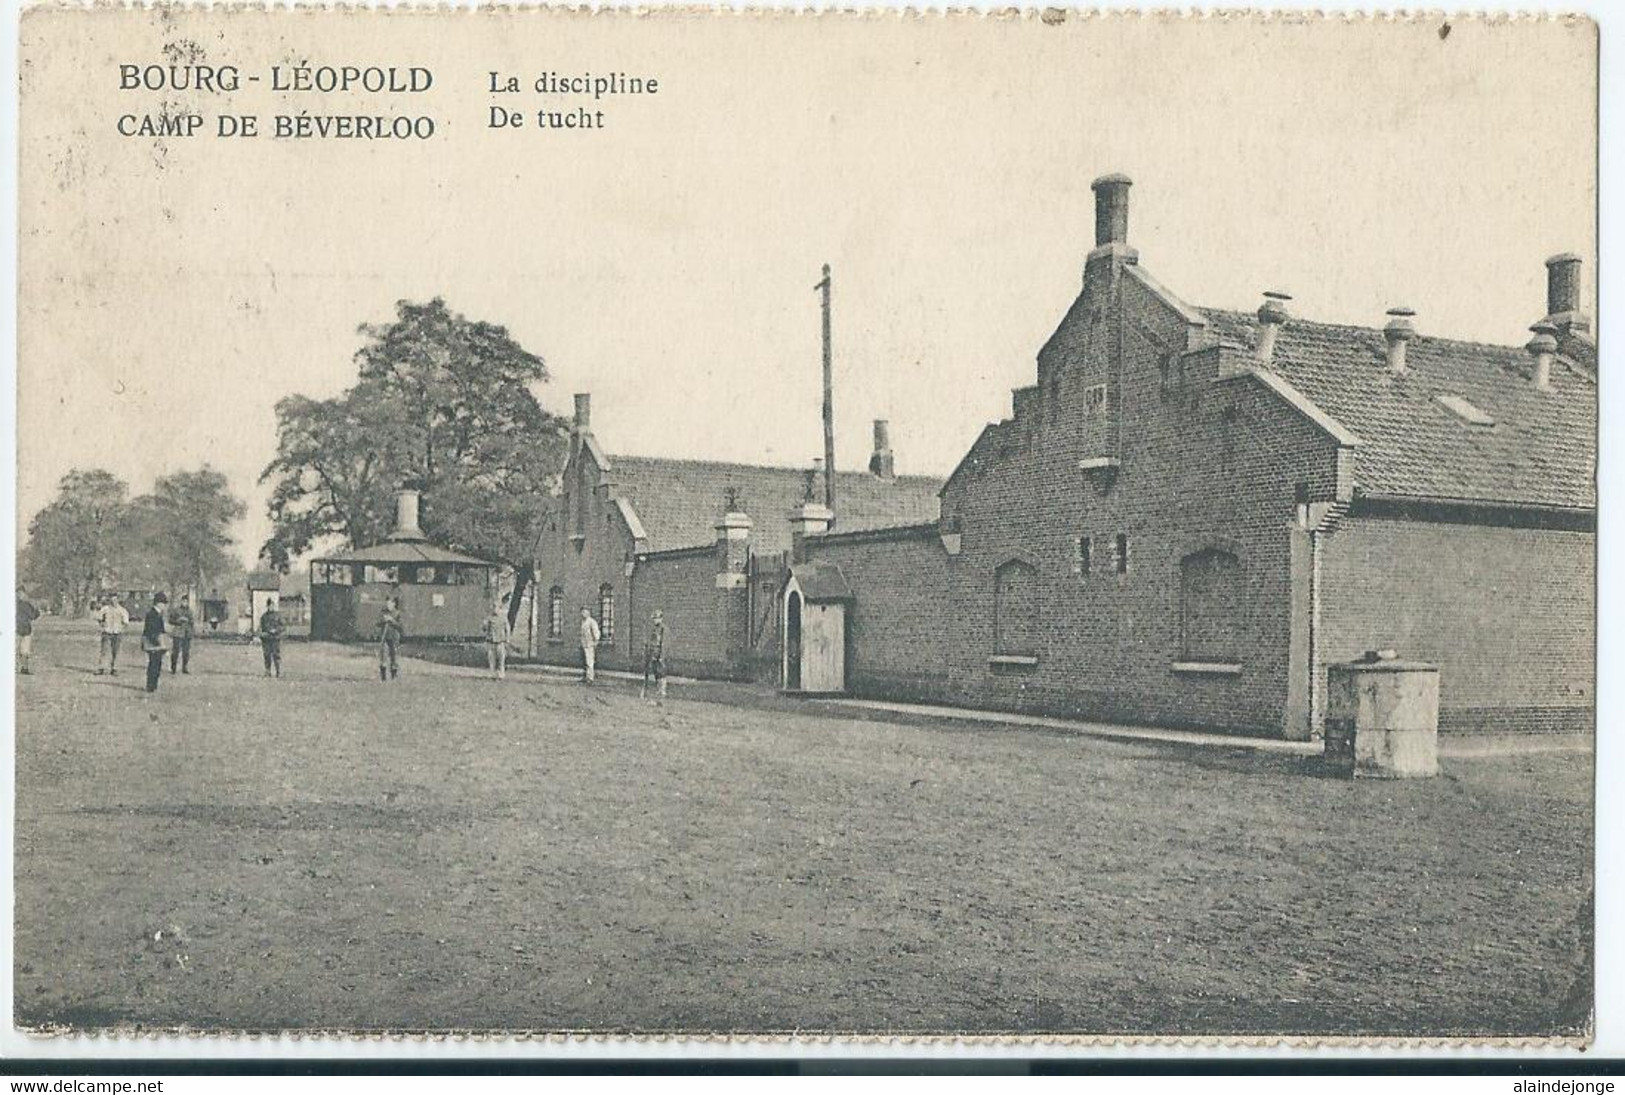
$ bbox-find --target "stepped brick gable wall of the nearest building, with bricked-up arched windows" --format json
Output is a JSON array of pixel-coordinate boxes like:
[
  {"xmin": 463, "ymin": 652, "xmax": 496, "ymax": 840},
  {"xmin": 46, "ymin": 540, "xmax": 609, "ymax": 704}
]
[{"xmin": 929, "ymin": 256, "xmax": 1339, "ymax": 736}]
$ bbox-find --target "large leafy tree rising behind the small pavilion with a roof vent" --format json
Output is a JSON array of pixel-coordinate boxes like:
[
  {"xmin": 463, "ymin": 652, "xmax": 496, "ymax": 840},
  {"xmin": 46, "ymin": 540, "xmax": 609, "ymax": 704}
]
[{"xmin": 260, "ymin": 297, "xmax": 567, "ymax": 619}]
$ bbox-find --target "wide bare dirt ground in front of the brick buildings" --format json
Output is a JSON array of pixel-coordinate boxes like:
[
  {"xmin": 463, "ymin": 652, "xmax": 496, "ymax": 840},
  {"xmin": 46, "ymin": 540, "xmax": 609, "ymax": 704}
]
[{"xmin": 15, "ymin": 627, "xmax": 1591, "ymax": 1033}]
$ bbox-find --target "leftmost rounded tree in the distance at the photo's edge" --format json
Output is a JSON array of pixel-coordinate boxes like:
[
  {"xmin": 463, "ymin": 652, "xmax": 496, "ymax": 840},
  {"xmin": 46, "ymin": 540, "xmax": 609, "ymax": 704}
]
[{"xmin": 21, "ymin": 468, "xmax": 130, "ymax": 616}]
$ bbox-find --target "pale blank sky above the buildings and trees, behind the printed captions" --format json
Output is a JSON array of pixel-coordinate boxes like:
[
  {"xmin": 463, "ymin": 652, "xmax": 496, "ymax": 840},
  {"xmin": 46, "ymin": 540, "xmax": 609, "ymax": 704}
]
[{"xmin": 18, "ymin": 11, "xmax": 1594, "ymax": 556}]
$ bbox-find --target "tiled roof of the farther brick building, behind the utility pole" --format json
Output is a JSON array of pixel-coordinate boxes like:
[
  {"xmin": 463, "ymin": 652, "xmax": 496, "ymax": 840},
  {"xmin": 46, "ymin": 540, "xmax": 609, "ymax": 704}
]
[{"xmin": 606, "ymin": 455, "xmax": 943, "ymax": 552}]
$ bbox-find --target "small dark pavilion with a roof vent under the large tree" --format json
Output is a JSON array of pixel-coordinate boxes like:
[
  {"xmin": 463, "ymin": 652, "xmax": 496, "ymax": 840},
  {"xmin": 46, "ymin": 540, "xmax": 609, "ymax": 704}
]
[{"xmin": 310, "ymin": 491, "xmax": 497, "ymax": 642}]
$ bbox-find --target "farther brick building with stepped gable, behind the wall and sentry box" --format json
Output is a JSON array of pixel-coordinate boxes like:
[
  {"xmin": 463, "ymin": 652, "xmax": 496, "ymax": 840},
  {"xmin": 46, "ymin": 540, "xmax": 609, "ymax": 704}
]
[{"xmin": 535, "ymin": 395, "xmax": 943, "ymax": 677}]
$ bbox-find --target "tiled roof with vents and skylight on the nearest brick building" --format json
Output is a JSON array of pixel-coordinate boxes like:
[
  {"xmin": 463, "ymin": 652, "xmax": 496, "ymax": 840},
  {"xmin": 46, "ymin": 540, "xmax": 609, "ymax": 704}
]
[{"xmin": 1204, "ymin": 309, "xmax": 1597, "ymax": 509}]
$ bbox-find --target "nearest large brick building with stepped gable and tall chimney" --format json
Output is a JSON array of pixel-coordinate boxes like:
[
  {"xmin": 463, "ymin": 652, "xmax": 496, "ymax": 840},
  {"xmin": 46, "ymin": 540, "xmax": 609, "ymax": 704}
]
[{"xmin": 804, "ymin": 175, "xmax": 1596, "ymax": 738}]
